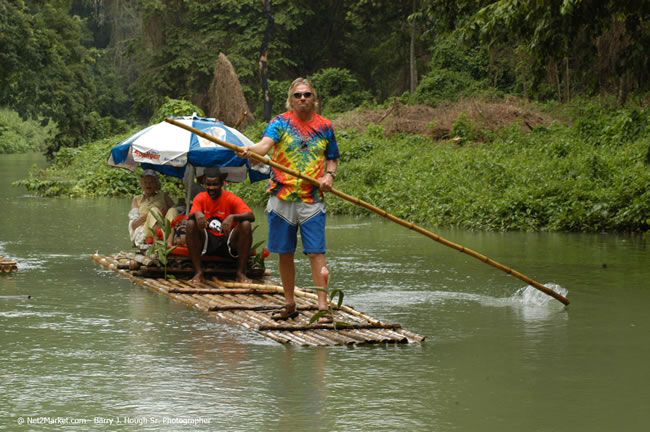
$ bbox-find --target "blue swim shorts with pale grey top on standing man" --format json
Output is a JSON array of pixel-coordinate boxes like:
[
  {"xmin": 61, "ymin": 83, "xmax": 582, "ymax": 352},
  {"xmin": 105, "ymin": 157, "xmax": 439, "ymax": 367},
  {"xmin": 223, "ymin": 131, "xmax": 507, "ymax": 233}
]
[{"xmin": 266, "ymin": 196, "xmax": 325, "ymax": 254}]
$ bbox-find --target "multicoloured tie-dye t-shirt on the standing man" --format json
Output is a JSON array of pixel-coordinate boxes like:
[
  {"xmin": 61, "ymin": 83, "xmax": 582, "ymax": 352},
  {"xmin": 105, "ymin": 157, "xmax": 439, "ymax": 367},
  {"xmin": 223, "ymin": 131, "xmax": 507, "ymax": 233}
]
[{"xmin": 263, "ymin": 111, "xmax": 339, "ymax": 202}]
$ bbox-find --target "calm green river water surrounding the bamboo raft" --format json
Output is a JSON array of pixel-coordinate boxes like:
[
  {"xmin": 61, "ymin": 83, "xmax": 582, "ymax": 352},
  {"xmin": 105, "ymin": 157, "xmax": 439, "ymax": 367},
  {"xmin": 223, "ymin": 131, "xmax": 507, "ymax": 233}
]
[{"xmin": 0, "ymin": 155, "xmax": 650, "ymax": 432}]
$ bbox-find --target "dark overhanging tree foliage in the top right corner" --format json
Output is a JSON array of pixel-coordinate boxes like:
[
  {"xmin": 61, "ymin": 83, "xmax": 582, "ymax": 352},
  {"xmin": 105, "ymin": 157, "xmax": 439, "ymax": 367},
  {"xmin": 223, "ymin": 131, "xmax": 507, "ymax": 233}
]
[{"xmin": 459, "ymin": 0, "xmax": 650, "ymax": 102}]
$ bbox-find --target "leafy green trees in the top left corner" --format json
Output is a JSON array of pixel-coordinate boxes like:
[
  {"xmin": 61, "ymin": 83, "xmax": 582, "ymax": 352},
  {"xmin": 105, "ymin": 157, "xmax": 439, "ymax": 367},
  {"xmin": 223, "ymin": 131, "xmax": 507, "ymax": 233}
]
[{"xmin": 0, "ymin": 0, "xmax": 129, "ymax": 153}]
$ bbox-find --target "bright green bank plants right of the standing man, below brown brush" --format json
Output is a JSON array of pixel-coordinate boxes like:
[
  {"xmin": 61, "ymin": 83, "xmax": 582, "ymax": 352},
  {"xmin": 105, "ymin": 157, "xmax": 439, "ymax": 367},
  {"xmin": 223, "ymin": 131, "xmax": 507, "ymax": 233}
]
[{"xmin": 328, "ymin": 104, "xmax": 650, "ymax": 231}]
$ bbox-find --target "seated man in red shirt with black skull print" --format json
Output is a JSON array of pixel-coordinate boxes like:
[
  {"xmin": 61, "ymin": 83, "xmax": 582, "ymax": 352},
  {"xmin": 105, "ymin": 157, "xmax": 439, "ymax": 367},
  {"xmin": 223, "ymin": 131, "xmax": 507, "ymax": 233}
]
[{"xmin": 185, "ymin": 167, "xmax": 255, "ymax": 282}]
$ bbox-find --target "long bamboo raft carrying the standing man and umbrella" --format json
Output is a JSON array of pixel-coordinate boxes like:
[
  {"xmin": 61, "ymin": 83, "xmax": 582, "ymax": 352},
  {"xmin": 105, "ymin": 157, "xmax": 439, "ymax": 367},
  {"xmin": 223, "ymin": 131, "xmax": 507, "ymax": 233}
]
[{"xmin": 92, "ymin": 253, "xmax": 425, "ymax": 346}]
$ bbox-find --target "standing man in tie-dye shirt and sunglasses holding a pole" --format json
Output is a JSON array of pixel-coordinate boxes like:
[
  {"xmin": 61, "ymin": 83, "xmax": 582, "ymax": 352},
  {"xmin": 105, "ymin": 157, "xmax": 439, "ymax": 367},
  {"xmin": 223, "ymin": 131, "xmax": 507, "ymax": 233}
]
[{"xmin": 239, "ymin": 78, "xmax": 339, "ymax": 322}]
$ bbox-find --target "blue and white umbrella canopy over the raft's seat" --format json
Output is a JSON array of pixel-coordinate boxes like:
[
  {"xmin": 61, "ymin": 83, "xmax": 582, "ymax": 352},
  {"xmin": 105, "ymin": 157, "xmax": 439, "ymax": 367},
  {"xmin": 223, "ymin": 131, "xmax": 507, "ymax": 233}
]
[{"xmin": 108, "ymin": 116, "xmax": 268, "ymax": 182}]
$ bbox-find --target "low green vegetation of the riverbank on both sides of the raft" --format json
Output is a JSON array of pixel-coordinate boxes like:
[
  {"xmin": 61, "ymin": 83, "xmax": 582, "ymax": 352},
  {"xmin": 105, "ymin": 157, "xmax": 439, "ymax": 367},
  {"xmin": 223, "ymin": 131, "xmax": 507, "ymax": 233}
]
[{"xmin": 12, "ymin": 97, "xmax": 650, "ymax": 232}]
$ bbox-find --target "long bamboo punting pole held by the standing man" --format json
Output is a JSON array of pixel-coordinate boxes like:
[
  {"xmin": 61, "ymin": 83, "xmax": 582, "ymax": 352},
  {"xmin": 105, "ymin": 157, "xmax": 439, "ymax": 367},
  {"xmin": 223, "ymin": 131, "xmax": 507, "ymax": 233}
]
[{"xmin": 165, "ymin": 117, "xmax": 570, "ymax": 305}]
